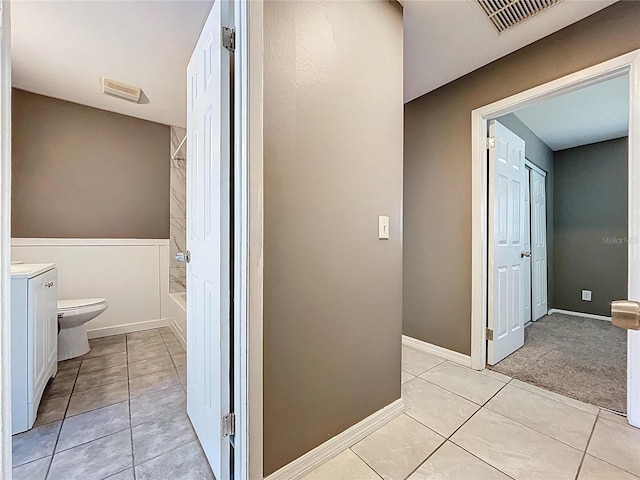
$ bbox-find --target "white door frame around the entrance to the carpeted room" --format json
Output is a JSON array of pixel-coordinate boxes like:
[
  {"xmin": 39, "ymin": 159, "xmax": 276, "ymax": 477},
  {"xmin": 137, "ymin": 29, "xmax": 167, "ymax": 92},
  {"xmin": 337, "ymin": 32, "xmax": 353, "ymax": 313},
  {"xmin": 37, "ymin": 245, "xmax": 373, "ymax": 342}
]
[{"xmin": 471, "ymin": 50, "xmax": 640, "ymax": 426}]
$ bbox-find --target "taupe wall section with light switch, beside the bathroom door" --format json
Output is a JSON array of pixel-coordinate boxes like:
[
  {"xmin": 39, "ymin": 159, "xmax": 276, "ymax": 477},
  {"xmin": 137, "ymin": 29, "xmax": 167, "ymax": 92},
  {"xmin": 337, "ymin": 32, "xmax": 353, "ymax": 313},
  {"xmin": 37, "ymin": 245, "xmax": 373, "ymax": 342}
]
[{"xmin": 264, "ymin": 1, "xmax": 403, "ymax": 475}]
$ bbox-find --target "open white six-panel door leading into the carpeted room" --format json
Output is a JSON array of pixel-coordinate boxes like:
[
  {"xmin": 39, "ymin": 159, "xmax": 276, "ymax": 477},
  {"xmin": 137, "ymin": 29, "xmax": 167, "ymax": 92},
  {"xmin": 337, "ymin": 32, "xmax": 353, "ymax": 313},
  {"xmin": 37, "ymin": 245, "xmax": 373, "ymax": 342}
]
[{"xmin": 487, "ymin": 120, "xmax": 527, "ymax": 365}]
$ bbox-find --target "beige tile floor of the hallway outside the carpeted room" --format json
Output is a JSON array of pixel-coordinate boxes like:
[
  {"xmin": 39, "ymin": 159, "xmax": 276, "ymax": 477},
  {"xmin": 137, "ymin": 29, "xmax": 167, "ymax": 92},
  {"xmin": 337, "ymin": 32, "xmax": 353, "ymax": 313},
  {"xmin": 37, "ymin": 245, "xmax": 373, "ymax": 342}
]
[{"xmin": 305, "ymin": 347, "xmax": 640, "ymax": 480}]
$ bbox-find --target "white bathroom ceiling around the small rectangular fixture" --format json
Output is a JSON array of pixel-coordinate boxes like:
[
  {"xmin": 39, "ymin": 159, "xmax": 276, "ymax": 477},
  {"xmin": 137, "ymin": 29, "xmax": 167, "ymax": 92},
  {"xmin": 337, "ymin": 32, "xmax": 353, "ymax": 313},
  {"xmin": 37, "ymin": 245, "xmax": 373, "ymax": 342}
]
[{"xmin": 11, "ymin": 1, "xmax": 213, "ymax": 127}]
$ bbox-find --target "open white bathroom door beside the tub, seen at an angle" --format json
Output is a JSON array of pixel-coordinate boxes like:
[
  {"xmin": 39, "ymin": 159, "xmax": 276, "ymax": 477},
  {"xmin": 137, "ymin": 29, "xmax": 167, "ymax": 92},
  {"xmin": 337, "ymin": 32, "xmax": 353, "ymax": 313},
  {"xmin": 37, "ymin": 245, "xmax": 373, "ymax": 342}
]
[{"xmin": 187, "ymin": 0, "xmax": 231, "ymax": 479}]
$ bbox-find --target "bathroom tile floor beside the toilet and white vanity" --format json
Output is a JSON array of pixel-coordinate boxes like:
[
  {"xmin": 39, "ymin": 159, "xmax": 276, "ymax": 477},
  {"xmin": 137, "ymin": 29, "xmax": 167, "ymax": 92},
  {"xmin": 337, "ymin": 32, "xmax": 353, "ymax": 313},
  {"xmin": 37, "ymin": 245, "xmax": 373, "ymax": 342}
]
[{"xmin": 13, "ymin": 328, "xmax": 213, "ymax": 480}]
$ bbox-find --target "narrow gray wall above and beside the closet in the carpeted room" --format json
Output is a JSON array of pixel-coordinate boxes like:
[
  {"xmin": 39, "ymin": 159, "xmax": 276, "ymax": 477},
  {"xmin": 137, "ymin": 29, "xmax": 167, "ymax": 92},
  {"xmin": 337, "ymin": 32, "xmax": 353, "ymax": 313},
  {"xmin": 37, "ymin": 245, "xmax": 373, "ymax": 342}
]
[{"xmin": 498, "ymin": 113, "xmax": 553, "ymax": 308}]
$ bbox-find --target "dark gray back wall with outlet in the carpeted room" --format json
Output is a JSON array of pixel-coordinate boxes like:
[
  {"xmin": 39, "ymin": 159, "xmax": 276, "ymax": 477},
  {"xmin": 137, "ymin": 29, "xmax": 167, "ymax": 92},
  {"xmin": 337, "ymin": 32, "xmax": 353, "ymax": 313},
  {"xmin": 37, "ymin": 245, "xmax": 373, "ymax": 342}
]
[{"xmin": 553, "ymin": 137, "xmax": 628, "ymax": 316}]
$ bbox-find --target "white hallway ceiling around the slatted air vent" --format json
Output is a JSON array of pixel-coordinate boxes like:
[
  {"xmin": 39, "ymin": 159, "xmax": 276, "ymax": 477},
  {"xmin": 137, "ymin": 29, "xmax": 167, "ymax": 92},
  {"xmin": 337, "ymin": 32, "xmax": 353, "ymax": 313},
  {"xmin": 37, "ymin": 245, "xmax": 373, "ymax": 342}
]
[{"xmin": 404, "ymin": 0, "xmax": 615, "ymax": 102}]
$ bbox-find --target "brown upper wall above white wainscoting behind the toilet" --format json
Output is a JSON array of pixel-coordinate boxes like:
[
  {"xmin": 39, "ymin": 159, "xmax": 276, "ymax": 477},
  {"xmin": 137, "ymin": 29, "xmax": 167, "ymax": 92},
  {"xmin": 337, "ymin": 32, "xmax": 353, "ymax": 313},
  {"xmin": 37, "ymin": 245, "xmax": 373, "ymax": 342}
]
[{"xmin": 11, "ymin": 89, "xmax": 169, "ymax": 238}]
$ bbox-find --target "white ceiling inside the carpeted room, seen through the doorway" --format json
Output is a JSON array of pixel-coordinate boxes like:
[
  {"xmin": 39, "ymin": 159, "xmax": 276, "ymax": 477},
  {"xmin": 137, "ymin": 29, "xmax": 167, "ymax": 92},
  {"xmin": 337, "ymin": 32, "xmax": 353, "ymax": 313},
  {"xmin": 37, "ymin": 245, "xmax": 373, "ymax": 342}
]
[{"xmin": 515, "ymin": 75, "xmax": 629, "ymax": 151}]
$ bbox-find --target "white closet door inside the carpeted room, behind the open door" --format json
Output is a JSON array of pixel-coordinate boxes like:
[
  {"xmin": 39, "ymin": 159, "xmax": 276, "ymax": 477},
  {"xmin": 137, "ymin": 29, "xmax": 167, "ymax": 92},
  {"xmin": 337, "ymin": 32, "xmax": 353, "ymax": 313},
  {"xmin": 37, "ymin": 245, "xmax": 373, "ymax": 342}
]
[{"xmin": 531, "ymin": 170, "xmax": 548, "ymax": 321}]
